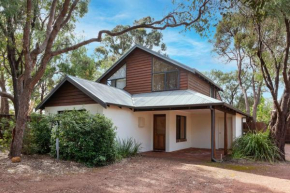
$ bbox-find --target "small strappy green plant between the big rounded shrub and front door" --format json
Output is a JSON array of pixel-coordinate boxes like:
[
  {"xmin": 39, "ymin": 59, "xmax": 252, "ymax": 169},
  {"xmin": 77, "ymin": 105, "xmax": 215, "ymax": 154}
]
[{"xmin": 116, "ymin": 138, "xmax": 141, "ymax": 158}]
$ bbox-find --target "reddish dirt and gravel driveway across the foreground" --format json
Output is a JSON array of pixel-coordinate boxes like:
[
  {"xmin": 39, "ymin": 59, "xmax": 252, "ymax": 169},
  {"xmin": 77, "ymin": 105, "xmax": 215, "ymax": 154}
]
[{"xmin": 0, "ymin": 145, "xmax": 290, "ymax": 193}]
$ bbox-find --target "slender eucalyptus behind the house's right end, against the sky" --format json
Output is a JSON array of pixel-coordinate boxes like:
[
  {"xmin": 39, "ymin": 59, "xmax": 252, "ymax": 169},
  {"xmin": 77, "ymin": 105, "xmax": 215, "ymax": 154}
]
[{"xmin": 214, "ymin": 12, "xmax": 263, "ymax": 121}]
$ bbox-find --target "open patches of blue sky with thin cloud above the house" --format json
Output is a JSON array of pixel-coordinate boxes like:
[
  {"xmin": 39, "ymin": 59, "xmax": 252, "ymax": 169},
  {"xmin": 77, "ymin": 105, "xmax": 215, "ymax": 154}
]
[{"xmin": 76, "ymin": 0, "xmax": 236, "ymax": 72}]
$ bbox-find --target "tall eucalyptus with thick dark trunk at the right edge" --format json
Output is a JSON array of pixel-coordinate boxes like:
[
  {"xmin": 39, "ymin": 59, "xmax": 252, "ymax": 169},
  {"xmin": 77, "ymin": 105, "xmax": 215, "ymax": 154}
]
[{"xmin": 247, "ymin": 0, "xmax": 290, "ymax": 160}]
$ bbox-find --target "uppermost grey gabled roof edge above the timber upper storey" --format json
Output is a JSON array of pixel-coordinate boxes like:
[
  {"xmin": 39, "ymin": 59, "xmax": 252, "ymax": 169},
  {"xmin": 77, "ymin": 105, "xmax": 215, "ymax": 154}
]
[{"xmin": 96, "ymin": 44, "xmax": 223, "ymax": 91}]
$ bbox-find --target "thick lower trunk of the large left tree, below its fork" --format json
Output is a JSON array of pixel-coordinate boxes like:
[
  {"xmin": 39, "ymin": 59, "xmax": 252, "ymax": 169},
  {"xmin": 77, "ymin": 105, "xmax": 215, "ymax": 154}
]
[{"xmin": 10, "ymin": 88, "xmax": 32, "ymax": 157}]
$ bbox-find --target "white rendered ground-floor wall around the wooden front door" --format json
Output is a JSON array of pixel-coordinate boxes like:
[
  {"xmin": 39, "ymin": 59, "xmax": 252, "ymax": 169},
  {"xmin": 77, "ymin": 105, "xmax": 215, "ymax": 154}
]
[{"xmin": 45, "ymin": 104, "xmax": 243, "ymax": 152}]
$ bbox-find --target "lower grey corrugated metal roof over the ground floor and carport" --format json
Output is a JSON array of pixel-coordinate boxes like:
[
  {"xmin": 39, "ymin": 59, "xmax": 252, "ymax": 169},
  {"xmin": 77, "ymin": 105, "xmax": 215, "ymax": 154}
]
[{"xmin": 36, "ymin": 76, "xmax": 249, "ymax": 116}]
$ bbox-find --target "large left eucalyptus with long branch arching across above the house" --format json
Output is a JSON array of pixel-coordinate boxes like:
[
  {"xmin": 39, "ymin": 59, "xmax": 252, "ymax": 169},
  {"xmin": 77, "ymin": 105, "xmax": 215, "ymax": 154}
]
[{"xmin": 0, "ymin": 0, "xmax": 218, "ymax": 157}]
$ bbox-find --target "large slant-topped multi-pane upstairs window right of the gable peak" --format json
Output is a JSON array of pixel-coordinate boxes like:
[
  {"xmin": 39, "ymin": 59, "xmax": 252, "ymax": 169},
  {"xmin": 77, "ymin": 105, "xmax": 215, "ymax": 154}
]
[{"xmin": 152, "ymin": 58, "xmax": 179, "ymax": 91}]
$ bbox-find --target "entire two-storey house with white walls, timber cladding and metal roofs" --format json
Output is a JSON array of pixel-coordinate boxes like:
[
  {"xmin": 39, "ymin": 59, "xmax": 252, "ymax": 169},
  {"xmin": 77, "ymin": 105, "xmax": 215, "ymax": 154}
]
[{"xmin": 37, "ymin": 45, "xmax": 248, "ymax": 161}]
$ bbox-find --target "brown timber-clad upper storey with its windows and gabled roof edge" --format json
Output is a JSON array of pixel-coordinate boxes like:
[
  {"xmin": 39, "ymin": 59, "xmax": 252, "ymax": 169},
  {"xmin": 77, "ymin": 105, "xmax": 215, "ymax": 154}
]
[{"xmin": 97, "ymin": 45, "xmax": 222, "ymax": 99}]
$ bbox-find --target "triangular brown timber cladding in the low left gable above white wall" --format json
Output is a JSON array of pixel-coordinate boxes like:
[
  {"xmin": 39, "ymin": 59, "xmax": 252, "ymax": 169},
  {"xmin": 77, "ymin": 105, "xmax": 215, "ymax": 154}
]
[{"xmin": 45, "ymin": 81, "xmax": 96, "ymax": 107}]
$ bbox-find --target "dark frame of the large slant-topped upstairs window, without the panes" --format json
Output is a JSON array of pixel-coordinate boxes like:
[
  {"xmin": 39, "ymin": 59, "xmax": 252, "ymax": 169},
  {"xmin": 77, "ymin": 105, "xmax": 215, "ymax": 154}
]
[{"xmin": 151, "ymin": 57, "xmax": 180, "ymax": 92}]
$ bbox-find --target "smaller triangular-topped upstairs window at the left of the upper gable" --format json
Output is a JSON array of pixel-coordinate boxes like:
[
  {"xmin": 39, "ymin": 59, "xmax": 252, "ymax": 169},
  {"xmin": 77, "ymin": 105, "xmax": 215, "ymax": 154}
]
[{"xmin": 107, "ymin": 64, "xmax": 126, "ymax": 89}]
